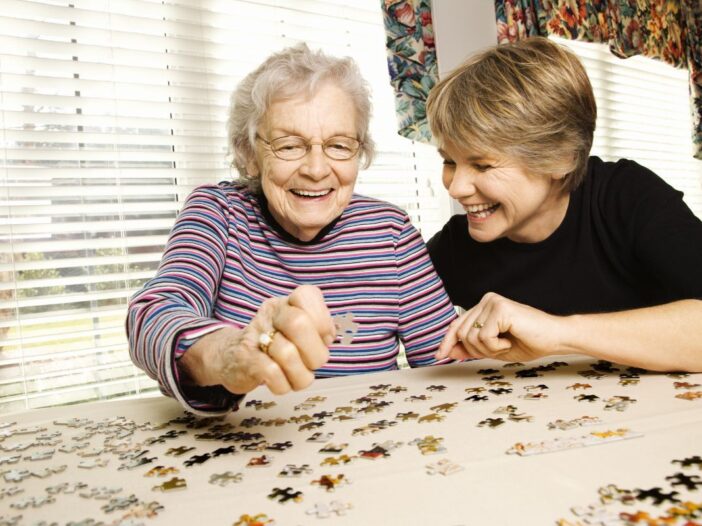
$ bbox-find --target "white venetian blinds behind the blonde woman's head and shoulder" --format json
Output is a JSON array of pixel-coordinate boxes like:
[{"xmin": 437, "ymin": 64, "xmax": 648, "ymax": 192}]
[{"xmin": 554, "ymin": 38, "xmax": 702, "ymax": 218}]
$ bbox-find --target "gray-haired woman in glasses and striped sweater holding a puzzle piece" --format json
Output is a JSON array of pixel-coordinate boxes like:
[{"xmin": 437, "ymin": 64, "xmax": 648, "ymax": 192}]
[{"xmin": 127, "ymin": 45, "xmax": 455, "ymax": 413}]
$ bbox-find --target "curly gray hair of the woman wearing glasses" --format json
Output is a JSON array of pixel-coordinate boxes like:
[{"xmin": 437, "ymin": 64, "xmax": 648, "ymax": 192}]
[{"xmin": 227, "ymin": 43, "xmax": 375, "ymax": 193}]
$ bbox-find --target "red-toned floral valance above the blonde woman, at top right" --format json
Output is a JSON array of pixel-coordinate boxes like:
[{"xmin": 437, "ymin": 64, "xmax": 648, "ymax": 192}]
[{"xmin": 495, "ymin": 0, "xmax": 702, "ymax": 159}]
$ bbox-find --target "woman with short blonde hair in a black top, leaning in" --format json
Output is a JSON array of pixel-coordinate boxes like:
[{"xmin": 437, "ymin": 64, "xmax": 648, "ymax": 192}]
[{"xmin": 428, "ymin": 38, "xmax": 702, "ymax": 371}]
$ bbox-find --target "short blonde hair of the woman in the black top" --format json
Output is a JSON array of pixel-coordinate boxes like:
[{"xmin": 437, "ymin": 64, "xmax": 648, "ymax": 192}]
[{"xmin": 427, "ymin": 37, "xmax": 597, "ymax": 192}]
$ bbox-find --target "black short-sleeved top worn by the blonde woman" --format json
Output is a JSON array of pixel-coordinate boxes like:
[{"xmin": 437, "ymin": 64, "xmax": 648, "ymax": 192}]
[{"xmin": 428, "ymin": 157, "xmax": 702, "ymax": 314}]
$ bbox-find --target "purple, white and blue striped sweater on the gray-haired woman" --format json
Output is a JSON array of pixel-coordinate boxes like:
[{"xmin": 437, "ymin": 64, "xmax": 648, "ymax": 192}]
[{"xmin": 127, "ymin": 183, "xmax": 455, "ymax": 413}]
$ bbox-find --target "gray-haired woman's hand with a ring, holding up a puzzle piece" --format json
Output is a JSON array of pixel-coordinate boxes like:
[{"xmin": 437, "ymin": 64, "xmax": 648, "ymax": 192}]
[{"xmin": 179, "ymin": 285, "xmax": 336, "ymax": 394}]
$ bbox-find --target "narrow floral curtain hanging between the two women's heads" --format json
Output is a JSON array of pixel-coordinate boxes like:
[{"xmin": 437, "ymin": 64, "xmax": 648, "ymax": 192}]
[{"xmin": 382, "ymin": 0, "xmax": 439, "ymax": 142}]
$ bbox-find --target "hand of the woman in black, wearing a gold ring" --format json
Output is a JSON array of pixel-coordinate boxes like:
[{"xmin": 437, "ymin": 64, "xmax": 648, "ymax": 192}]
[{"xmin": 436, "ymin": 292, "xmax": 564, "ymax": 362}]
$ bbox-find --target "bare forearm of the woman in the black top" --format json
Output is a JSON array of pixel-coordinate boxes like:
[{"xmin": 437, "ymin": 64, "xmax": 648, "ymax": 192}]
[{"xmin": 558, "ymin": 300, "xmax": 702, "ymax": 372}]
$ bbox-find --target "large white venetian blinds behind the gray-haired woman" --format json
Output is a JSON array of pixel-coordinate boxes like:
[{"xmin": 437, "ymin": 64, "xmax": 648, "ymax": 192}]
[{"xmin": 0, "ymin": 0, "xmax": 448, "ymax": 412}]
